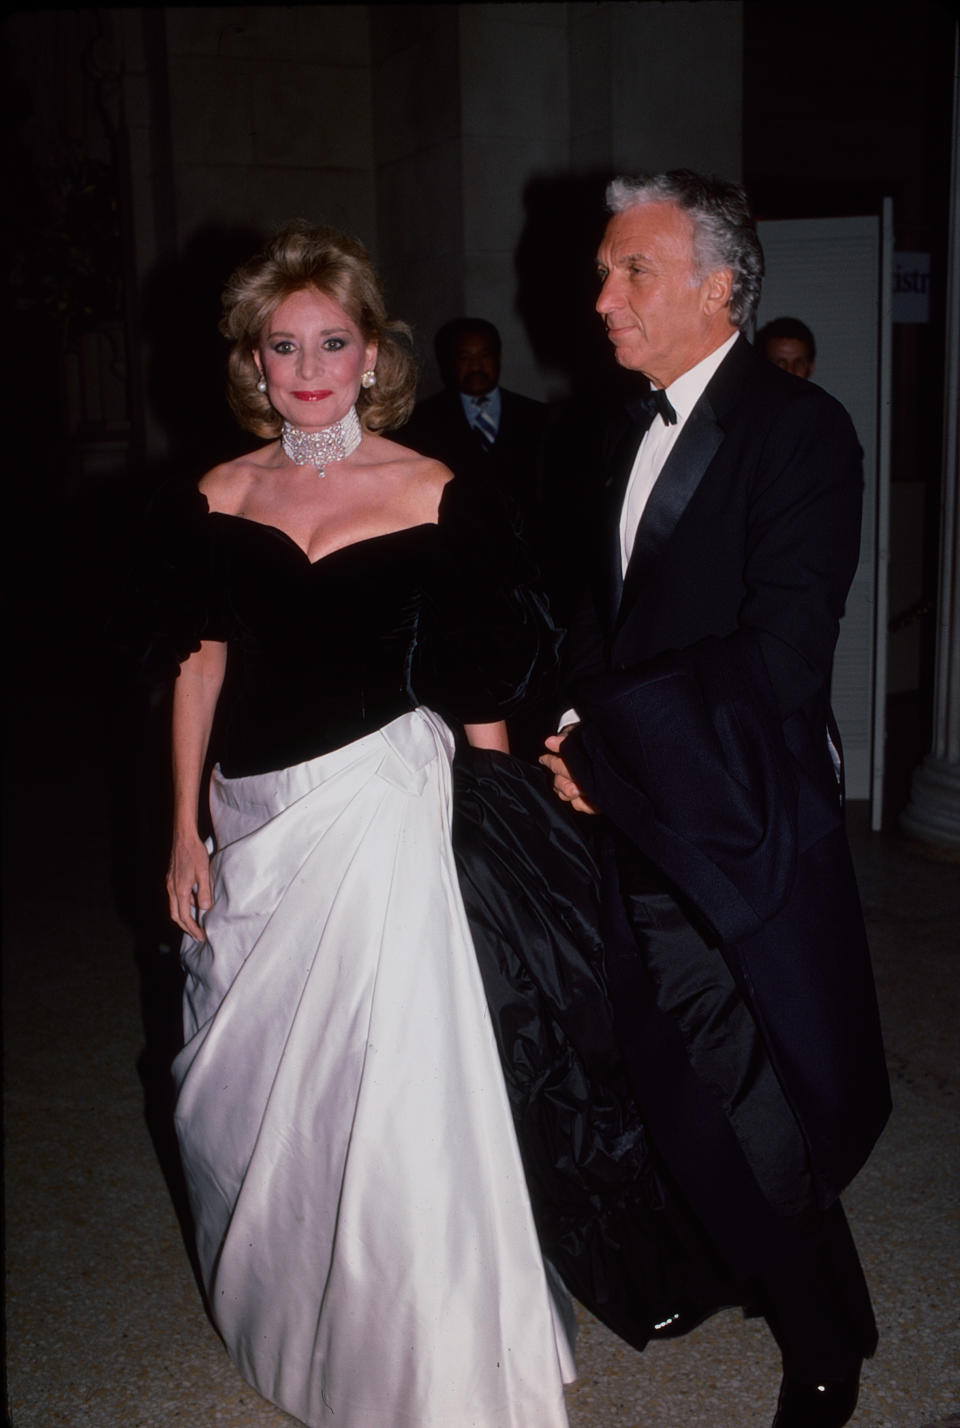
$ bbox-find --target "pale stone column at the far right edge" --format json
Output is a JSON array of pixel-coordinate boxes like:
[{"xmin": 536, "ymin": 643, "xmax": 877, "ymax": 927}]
[{"xmin": 900, "ymin": 39, "xmax": 960, "ymax": 857}]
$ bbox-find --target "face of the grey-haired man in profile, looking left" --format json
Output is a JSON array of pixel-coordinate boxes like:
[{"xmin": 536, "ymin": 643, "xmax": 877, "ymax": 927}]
[{"xmin": 597, "ymin": 203, "xmax": 734, "ymax": 387}]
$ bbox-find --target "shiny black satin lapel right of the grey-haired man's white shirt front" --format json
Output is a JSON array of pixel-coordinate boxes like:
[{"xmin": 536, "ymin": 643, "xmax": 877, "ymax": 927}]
[{"xmin": 619, "ymin": 394, "xmax": 723, "ymax": 623}]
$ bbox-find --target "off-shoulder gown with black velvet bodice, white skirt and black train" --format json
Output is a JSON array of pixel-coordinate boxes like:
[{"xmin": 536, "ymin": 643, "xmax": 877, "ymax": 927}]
[{"xmin": 150, "ymin": 481, "xmax": 729, "ymax": 1428}]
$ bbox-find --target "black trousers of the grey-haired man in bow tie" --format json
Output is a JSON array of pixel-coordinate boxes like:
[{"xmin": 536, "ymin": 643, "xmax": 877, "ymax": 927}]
[{"xmin": 601, "ymin": 843, "xmax": 876, "ymax": 1382}]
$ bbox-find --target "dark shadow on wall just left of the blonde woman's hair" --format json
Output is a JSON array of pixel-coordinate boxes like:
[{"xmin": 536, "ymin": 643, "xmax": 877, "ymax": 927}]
[{"xmin": 141, "ymin": 224, "xmax": 264, "ymax": 477}]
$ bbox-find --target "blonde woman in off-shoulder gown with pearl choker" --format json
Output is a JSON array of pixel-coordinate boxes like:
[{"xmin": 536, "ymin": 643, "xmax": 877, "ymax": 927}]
[{"xmin": 156, "ymin": 224, "xmax": 571, "ymax": 1428}]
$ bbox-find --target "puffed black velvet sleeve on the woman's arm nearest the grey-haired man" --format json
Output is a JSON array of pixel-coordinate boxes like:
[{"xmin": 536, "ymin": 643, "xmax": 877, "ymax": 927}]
[{"xmin": 413, "ymin": 478, "xmax": 560, "ymax": 724}]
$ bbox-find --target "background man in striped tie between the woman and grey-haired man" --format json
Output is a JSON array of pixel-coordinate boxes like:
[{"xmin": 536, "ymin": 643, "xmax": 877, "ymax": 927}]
[{"xmin": 397, "ymin": 317, "xmax": 547, "ymax": 521}]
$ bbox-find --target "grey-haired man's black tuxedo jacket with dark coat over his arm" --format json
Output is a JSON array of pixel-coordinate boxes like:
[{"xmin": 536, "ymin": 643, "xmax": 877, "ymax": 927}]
[{"xmin": 564, "ymin": 338, "xmax": 889, "ymax": 1204}]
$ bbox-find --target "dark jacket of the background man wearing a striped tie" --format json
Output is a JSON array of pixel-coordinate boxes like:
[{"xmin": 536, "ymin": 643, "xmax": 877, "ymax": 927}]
[{"xmin": 396, "ymin": 387, "xmax": 547, "ymax": 514}]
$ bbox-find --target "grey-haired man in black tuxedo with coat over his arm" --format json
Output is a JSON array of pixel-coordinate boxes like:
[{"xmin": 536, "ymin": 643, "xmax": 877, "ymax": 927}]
[{"xmin": 541, "ymin": 170, "xmax": 889, "ymax": 1428}]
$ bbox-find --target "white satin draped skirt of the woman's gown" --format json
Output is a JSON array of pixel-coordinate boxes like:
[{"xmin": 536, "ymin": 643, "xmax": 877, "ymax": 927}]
[{"xmin": 173, "ymin": 708, "xmax": 573, "ymax": 1428}]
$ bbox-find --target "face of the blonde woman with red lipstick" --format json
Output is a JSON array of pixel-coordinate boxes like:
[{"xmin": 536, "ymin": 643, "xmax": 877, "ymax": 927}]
[{"xmin": 254, "ymin": 287, "xmax": 377, "ymax": 430}]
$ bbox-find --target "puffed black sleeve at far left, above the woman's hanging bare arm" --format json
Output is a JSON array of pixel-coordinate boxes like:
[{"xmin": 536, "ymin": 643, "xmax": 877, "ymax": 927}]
[{"xmin": 133, "ymin": 483, "xmax": 234, "ymax": 685}]
